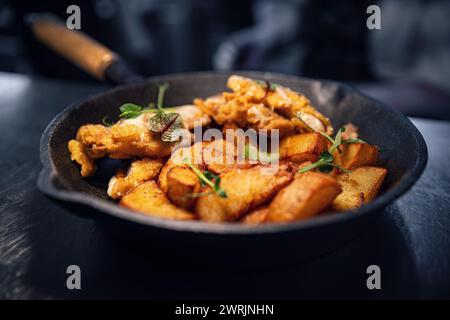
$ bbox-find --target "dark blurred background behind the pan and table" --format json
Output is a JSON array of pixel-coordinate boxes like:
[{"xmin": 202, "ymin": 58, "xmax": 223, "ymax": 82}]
[{"xmin": 0, "ymin": 0, "xmax": 450, "ymax": 120}]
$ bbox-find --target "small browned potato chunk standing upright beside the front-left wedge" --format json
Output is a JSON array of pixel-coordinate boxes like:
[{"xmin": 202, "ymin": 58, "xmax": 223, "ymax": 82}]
[{"xmin": 167, "ymin": 166, "xmax": 201, "ymax": 210}]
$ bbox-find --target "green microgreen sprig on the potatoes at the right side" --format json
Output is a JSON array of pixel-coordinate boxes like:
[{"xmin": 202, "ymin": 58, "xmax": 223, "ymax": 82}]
[{"xmin": 299, "ymin": 127, "xmax": 364, "ymax": 173}]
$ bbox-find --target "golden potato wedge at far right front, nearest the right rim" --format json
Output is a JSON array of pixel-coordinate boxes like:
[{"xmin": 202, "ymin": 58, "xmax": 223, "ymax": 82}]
[{"xmin": 331, "ymin": 167, "xmax": 387, "ymax": 211}]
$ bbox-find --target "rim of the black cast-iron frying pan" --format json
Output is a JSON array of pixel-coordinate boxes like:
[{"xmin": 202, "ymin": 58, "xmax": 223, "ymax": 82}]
[{"xmin": 37, "ymin": 70, "xmax": 428, "ymax": 235}]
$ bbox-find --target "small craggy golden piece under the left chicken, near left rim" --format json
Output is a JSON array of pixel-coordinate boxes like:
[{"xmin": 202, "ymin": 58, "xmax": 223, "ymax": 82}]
[{"xmin": 107, "ymin": 158, "xmax": 163, "ymax": 199}]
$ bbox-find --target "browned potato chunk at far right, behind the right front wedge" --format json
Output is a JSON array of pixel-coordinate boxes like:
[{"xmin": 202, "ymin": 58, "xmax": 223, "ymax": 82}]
[{"xmin": 333, "ymin": 143, "xmax": 378, "ymax": 170}]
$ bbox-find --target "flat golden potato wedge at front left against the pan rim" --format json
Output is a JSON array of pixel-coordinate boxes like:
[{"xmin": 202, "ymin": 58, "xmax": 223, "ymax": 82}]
[{"xmin": 119, "ymin": 180, "xmax": 195, "ymax": 220}]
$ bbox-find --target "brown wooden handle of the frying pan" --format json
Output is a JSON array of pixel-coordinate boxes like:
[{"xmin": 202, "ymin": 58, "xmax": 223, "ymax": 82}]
[{"xmin": 30, "ymin": 14, "xmax": 119, "ymax": 80}]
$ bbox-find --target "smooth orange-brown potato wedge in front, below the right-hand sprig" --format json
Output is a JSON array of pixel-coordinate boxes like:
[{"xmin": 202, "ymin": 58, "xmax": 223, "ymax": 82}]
[{"xmin": 267, "ymin": 172, "xmax": 341, "ymax": 222}]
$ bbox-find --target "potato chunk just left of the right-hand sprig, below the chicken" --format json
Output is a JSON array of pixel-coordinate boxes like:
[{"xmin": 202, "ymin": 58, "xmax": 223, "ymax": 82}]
[{"xmin": 280, "ymin": 132, "xmax": 327, "ymax": 162}]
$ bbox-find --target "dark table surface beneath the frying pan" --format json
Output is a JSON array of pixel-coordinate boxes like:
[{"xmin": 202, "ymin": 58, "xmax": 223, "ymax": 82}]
[{"xmin": 0, "ymin": 73, "xmax": 450, "ymax": 299}]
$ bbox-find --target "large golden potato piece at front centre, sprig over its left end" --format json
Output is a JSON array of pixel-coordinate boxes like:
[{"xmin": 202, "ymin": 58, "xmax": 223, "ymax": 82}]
[{"xmin": 194, "ymin": 166, "xmax": 292, "ymax": 222}]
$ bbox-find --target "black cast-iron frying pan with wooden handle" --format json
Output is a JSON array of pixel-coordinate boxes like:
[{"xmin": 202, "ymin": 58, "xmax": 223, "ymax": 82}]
[{"xmin": 32, "ymin": 16, "xmax": 427, "ymax": 267}]
